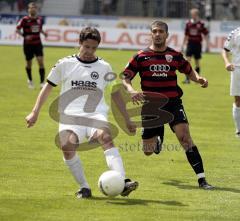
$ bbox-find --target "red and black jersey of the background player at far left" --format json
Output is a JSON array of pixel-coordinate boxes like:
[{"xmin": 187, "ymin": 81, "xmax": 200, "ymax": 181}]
[{"xmin": 17, "ymin": 16, "xmax": 43, "ymax": 45}]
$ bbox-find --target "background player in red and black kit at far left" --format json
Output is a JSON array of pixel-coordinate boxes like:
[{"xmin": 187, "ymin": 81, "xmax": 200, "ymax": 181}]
[{"xmin": 16, "ymin": 2, "xmax": 47, "ymax": 89}]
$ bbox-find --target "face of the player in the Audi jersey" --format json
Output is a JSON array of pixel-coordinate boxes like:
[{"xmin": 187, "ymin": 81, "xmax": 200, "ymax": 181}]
[{"xmin": 151, "ymin": 26, "xmax": 168, "ymax": 47}]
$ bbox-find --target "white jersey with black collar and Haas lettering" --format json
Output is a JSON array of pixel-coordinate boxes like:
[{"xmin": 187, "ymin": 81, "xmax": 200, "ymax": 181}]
[{"xmin": 47, "ymin": 55, "xmax": 112, "ymax": 116}]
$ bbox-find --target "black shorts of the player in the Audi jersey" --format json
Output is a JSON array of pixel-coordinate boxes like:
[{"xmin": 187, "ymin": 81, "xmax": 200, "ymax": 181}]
[{"xmin": 142, "ymin": 99, "xmax": 188, "ymax": 140}]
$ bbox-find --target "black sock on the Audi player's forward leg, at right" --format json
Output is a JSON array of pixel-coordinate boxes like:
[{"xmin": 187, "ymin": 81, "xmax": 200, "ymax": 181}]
[{"xmin": 186, "ymin": 146, "xmax": 204, "ymax": 174}]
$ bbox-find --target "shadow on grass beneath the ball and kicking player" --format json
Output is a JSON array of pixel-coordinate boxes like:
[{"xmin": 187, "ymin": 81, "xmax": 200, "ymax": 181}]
[{"xmin": 89, "ymin": 197, "xmax": 188, "ymax": 206}]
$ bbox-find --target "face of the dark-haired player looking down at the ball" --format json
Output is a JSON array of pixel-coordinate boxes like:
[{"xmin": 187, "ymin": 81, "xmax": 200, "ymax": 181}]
[{"xmin": 80, "ymin": 39, "xmax": 99, "ymax": 61}]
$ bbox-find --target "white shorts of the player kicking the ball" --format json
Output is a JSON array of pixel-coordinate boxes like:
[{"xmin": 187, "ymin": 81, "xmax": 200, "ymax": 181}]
[{"xmin": 59, "ymin": 114, "xmax": 108, "ymax": 144}]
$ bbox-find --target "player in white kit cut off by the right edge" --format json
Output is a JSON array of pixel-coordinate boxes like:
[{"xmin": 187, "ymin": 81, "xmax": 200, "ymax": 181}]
[{"xmin": 222, "ymin": 27, "xmax": 240, "ymax": 138}]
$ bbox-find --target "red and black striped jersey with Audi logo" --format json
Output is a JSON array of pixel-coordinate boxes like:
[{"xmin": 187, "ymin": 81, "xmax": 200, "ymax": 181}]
[{"xmin": 124, "ymin": 47, "xmax": 192, "ymax": 98}]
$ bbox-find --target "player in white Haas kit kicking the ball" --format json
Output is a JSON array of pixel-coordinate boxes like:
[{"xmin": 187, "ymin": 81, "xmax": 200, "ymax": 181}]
[{"xmin": 26, "ymin": 27, "xmax": 138, "ymax": 198}]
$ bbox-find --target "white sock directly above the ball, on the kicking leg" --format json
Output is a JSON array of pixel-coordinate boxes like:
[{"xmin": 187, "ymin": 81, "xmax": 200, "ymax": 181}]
[{"xmin": 104, "ymin": 147, "xmax": 125, "ymax": 178}]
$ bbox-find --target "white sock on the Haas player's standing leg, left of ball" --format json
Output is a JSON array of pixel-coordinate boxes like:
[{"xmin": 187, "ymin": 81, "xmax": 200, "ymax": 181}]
[{"xmin": 63, "ymin": 154, "xmax": 89, "ymax": 188}]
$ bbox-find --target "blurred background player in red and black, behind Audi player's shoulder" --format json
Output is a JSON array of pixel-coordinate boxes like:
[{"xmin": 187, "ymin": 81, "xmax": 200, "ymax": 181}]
[{"xmin": 182, "ymin": 8, "xmax": 209, "ymax": 84}]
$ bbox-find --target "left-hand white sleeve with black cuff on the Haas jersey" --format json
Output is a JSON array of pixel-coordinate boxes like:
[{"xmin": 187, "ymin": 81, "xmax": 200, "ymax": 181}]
[{"xmin": 47, "ymin": 59, "xmax": 63, "ymax": 86}]
